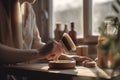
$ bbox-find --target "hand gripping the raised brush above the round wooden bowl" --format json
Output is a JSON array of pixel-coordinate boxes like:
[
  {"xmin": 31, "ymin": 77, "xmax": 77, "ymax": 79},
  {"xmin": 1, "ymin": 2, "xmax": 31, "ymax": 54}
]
[{"xmin": 39, "ymin": 40, "xmax": 63, "ymax": 60}]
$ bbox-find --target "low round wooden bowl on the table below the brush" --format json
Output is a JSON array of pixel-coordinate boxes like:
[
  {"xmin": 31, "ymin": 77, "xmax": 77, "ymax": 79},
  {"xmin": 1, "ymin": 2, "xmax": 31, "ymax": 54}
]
[{"xmin": 48, "ymin": 60, "xmax": 76, "ymax": 69}]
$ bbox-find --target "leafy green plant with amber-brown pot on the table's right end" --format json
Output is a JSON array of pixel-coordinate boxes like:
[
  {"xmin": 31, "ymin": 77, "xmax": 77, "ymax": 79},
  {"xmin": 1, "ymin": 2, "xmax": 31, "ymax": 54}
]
[{"xmin": 97, "ymin": 16, "xmax": 120, "ymax": 68}]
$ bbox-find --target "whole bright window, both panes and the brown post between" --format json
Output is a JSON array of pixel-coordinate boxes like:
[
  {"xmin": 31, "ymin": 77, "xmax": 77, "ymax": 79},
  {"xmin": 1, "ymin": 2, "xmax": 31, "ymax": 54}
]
[{"xmin": 48, "ymin": 0, "xmax": 119, "ymax": 42}]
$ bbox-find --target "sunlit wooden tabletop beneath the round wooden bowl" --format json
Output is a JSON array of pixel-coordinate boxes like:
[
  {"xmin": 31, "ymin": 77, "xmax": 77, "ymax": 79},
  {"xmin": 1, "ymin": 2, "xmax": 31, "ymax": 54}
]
[{"xmin": 2, "ymin": 63, "xmax": 111, "ymax": 80}]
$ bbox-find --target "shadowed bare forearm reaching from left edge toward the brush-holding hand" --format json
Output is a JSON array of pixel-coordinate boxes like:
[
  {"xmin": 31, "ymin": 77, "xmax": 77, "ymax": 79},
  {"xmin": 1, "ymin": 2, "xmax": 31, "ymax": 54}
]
[{"xmin": 0, "ymin": 44, "xmax": 43, "ymax": 64}]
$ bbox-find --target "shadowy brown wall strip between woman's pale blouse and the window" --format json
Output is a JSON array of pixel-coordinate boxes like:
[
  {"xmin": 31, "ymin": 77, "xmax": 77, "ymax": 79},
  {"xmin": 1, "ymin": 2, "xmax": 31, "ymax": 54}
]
[{"xmin": 33, "ymin": 0, "xmax": 49, "ymax": 42}]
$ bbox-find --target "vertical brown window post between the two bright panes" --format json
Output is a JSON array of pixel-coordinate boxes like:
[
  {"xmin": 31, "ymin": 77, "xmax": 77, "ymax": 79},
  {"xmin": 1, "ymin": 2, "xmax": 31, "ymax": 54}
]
[{"xmin": 83, "ymin": 0, "xmax": 98, "ymax": 43}]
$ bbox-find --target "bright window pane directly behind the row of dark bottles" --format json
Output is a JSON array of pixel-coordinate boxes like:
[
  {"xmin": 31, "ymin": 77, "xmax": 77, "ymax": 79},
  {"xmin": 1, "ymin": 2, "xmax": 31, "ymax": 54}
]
[{"xmin": 53, "ymin": 0, "xmax": 83, "ymax": 37}]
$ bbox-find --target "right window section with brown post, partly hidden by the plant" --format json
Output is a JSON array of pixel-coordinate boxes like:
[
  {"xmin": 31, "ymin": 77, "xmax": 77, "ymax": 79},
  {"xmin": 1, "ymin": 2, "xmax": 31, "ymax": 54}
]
[{"xmin": 83, "ymin": 0, "xmax": 120, "ymax": 42}]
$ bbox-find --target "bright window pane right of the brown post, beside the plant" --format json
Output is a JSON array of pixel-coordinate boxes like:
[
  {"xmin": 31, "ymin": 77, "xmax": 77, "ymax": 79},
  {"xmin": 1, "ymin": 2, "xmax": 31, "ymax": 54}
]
[{"xmin": 92, "ymin": 0, "xmax": 117, "ymax": 35}]
